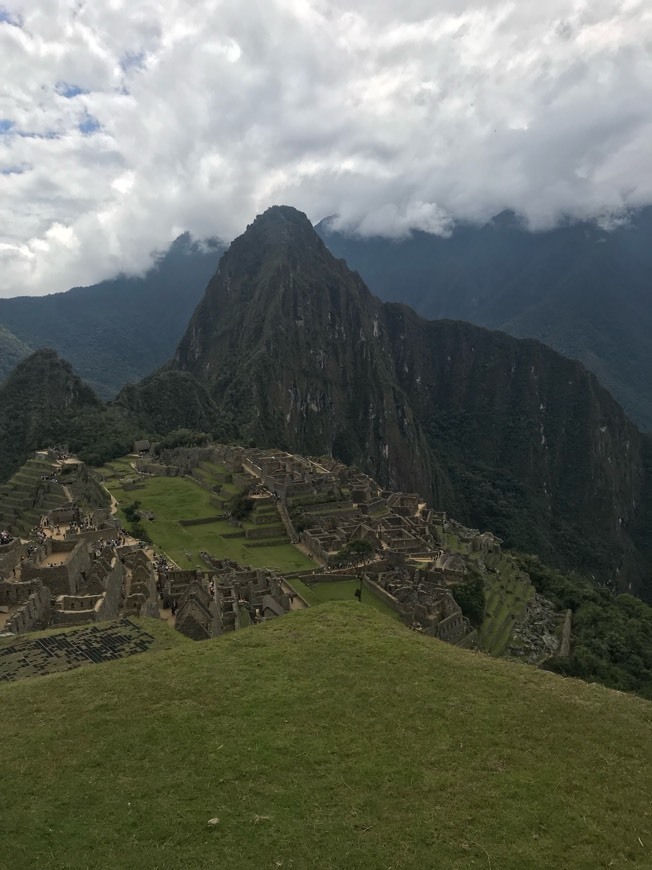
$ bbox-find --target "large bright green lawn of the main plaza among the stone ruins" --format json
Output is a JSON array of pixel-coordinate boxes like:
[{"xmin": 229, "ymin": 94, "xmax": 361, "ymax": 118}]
[{"xmin": 100, "ymin": 460, "xmax": 315, "ymax": 571}]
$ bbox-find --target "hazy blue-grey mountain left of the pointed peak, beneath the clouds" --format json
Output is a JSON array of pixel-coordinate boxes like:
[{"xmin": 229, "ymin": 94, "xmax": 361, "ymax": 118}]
[{"xmin": 0, "ymin": 234, "xmax": 223, "ymax": 398}]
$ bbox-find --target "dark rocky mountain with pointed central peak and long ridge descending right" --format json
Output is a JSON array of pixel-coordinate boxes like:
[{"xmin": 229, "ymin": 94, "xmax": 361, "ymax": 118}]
[{"xmin": 146, "ymin": 207, "xmax": 652, "ymax": 591}]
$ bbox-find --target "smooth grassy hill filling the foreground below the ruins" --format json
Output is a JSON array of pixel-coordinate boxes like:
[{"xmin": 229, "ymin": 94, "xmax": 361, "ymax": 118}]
[{"xmin": 0, "ymin": 602, "xmax": 652, "ymax": 870}]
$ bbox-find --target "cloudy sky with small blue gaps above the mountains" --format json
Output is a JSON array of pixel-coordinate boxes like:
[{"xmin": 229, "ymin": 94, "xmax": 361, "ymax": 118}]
[{"xmin": 0, "ymin": 0, "xmax": 652, "ymax": 296}]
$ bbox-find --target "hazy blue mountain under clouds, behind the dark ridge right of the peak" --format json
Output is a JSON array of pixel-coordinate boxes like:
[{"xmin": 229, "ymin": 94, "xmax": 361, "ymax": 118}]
[{"xmin": 317, "ymin": 208, "xmax": 652, "ymax": 430}]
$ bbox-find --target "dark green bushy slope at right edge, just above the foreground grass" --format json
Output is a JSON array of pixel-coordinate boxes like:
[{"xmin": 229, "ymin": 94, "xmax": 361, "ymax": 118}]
[{"xmin": 521, "ymin": 556, "xmax": 652, "ymax": 699}]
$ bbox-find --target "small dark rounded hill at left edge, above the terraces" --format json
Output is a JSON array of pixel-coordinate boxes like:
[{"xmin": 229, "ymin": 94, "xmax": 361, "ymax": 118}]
[{"xmin": 0, "ymin": 350, "xmax": 137, "ymax": 481}]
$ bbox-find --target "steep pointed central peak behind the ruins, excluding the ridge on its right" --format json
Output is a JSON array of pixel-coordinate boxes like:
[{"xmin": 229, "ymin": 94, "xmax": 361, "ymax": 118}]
[{"xmin": 175, "ymin": 207, "xmax": 439, "ymax": 493}]
